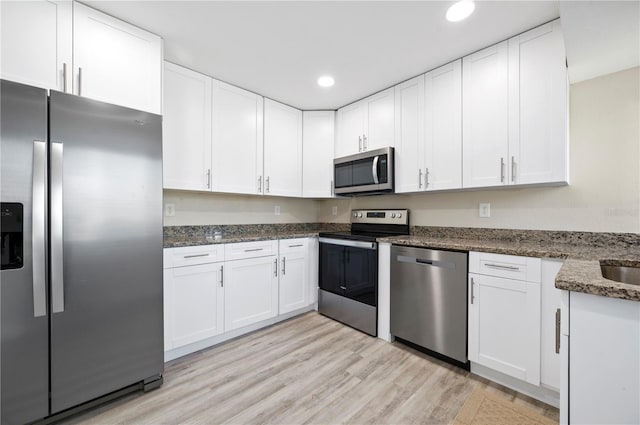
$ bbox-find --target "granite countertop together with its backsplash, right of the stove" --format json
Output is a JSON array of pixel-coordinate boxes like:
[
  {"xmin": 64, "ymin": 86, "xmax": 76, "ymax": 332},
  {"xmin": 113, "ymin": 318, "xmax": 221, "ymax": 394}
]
[{"xmin": 379, "ymin": 227, "xmax": 640, "ymax": 301}]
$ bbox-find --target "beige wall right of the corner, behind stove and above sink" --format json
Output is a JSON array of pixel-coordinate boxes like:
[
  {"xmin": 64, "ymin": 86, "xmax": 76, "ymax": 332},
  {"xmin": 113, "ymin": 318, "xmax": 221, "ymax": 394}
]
[{"xmin": 318, "ymin": 67, "xmax": 640, "ymax": 233}]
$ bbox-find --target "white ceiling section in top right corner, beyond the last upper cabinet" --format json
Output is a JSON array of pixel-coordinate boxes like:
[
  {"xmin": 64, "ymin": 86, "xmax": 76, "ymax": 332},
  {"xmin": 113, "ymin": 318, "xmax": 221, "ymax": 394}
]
[{"xmin": 560, "ymin": 0, "xmax": 640, "ymax": 83}]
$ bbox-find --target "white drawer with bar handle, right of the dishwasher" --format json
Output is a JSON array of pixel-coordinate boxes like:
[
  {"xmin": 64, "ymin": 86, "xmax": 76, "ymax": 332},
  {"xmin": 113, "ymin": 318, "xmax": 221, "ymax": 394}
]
[{"xmin": 469, "ymin": 252, "xmax": 542, "ymax": 283}]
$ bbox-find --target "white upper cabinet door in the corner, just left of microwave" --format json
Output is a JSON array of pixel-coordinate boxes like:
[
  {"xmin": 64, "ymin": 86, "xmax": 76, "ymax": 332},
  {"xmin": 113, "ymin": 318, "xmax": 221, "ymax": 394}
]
[{"xmin": 302, "ymin": 111, "xmax": 335, "ymax": 198}]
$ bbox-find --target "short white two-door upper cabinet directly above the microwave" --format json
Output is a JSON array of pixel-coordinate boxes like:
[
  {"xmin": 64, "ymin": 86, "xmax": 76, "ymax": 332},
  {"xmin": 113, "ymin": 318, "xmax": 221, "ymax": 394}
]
[{"xmin": 335, "ymin": 87, "xmax": 395, "ymax": 158}]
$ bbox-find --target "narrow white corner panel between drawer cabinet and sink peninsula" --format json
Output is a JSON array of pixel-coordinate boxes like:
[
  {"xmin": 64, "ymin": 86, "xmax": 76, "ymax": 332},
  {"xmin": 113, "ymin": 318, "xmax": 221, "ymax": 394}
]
[{"xmin": 540, "ymin": 259, "xmax": 562, "ymax": 391}]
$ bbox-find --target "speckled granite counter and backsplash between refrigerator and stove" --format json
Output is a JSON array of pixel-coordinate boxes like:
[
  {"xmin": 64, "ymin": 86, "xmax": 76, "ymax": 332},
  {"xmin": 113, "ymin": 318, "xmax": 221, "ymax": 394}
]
[{"xmin": 164, "ymin": 223, "xmax": 350, "ymax": 248}]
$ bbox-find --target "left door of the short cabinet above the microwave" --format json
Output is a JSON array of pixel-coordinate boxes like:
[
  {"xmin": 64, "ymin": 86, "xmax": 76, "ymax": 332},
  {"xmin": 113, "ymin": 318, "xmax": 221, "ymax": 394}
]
[{"xmin": 335, "ymin": 101, "xmax": 367, "ymax": 158}]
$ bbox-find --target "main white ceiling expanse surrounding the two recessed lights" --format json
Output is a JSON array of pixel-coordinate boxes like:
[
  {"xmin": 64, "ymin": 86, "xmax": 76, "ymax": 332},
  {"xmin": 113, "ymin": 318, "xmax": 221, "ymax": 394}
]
[{"xmin": 85, "ymin": 1, "xmax": 559, "ymax": 110}]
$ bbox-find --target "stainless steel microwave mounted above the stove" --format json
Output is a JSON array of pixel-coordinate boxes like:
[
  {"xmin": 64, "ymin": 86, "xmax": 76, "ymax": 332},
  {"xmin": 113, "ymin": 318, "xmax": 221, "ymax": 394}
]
[{"xmin": 333, "ymin": 147, "xmax": 394, "ymax": 195}]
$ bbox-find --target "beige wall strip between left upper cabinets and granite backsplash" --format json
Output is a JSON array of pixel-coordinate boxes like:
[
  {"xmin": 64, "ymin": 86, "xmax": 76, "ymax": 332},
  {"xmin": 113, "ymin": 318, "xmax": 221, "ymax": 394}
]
[{"xmin": 164, "ymin": 190, "xmax": 319, "ymax": 226}]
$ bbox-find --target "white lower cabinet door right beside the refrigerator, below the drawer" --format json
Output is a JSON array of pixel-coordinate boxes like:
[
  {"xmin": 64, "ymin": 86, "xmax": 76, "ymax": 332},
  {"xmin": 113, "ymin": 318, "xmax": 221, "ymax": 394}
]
[{"xmin": 164, "ymin": 263, "xmax": 224, "ymax": 350}]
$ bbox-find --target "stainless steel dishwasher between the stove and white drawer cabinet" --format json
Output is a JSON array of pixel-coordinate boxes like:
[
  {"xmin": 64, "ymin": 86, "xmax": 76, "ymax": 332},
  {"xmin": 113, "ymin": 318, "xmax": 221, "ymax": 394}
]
[{"xmin": 391, "ymin": 245, "xmax": 468, "ymax": 365}]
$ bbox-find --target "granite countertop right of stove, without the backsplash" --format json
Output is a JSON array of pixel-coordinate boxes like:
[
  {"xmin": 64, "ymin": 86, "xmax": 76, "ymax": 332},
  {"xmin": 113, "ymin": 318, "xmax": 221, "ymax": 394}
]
[{"xmin": 379, "ymin": 234, "xmax": 640, "ymax": 301}]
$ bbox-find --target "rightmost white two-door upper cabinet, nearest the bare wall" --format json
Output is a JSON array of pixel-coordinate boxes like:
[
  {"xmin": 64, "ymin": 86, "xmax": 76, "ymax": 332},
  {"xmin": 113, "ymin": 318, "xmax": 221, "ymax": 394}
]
[{"xmin": 463, "ymin": 21, "xmax": 568, "ymax": 187}]
